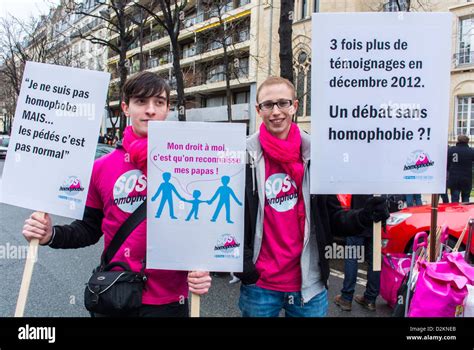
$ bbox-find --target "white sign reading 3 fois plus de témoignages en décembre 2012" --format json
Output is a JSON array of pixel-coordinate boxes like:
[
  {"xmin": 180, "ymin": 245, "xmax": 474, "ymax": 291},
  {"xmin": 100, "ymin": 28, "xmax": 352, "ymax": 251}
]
[{"xmin": 311, "ymin": 12, "xmax": 452, "ymax": 194}]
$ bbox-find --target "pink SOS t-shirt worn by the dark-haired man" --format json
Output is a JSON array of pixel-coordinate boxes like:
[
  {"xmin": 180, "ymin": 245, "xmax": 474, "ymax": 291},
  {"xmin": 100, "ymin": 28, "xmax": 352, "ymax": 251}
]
[{"xmin": 86, "ymin": 149, "xmax": 188, "ymax": 305}]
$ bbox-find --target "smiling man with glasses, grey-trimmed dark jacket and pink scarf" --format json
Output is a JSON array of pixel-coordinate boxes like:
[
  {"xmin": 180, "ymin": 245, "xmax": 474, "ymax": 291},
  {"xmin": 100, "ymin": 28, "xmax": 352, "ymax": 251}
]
[{"xmin": 236, "ymin": 77, "xmax": 389, "ymax": 317}]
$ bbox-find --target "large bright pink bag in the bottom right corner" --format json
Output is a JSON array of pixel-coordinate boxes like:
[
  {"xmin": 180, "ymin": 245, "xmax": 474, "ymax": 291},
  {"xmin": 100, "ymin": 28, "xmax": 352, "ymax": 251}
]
[{"xmin": 408, "ymin": 253, "xmax": 474, "ymax": 317}]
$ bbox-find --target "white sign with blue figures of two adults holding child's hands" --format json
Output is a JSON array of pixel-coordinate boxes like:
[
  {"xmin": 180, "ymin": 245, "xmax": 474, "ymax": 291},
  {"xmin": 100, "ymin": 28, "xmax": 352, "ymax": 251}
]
[{"xmin": 146, "ymin": 122, "xmax": 246, "ymax": 272}]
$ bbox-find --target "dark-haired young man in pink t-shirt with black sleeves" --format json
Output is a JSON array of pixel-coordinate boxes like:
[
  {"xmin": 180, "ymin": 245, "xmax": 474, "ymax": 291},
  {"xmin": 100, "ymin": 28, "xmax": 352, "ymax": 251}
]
[{"xmin": 23, "ymin": 72, "xmax": 211, "ymax": 317}]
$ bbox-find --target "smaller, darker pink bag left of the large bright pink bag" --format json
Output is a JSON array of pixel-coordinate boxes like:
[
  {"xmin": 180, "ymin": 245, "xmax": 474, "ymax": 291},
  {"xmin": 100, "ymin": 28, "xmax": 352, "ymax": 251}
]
[{"xmin": 380, "ymin": 253, "xmax": 411, "ymax": 308}]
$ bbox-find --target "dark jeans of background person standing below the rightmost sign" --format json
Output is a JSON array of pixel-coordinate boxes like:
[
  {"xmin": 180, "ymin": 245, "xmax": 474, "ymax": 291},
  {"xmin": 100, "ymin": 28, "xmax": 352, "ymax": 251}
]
[{"xmin": 341, "ymin": 236, "xmax": 380, "ymax": 303}]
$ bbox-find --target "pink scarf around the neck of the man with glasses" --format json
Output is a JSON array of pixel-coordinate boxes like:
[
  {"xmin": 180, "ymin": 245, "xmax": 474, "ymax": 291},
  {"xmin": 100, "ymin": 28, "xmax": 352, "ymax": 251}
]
[{"xmin": 259, "ymin": 123, "xmax": 306, "ymax": 234}]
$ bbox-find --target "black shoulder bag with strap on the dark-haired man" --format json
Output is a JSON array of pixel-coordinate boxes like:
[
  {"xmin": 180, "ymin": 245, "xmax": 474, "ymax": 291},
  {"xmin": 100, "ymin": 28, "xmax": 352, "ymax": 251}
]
[{"xmin": 84, "ymin": 201, "xmax": 146, "ymax": 316}]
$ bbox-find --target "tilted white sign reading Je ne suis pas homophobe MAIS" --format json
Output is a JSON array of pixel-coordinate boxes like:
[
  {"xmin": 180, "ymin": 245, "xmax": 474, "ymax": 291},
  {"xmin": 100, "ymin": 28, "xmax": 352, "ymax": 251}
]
[{"xmin": 2, "ymin": 62, "xmax": 110, "ymax": 219}]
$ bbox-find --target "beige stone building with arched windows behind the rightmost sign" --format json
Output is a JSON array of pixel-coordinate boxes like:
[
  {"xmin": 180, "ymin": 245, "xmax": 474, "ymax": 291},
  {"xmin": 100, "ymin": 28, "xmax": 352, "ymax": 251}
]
[{"xmin": 257, "ymin": 0, "xmax": 474, "ymax": 135}]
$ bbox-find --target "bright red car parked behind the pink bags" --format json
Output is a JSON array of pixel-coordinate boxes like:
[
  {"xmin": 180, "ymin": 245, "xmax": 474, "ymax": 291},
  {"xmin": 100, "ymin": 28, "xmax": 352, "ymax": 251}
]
[{"xmin": 382, "ymin": 203, "xmax": 474, "ymax": 253}]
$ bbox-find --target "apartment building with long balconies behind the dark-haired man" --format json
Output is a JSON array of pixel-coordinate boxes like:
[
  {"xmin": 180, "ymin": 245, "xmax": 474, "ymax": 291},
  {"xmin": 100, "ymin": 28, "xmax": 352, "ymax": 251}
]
[{"xmin": 108, "ymin": 0, "xmax": 258, "ymax": 133}]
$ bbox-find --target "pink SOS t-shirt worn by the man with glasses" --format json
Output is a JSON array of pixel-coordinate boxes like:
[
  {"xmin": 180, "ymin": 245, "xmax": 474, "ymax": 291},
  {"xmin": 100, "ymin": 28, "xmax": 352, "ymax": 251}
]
[{"xmin": 256, "ymin": 157, "xmax": 304, "ymax": 292}]
